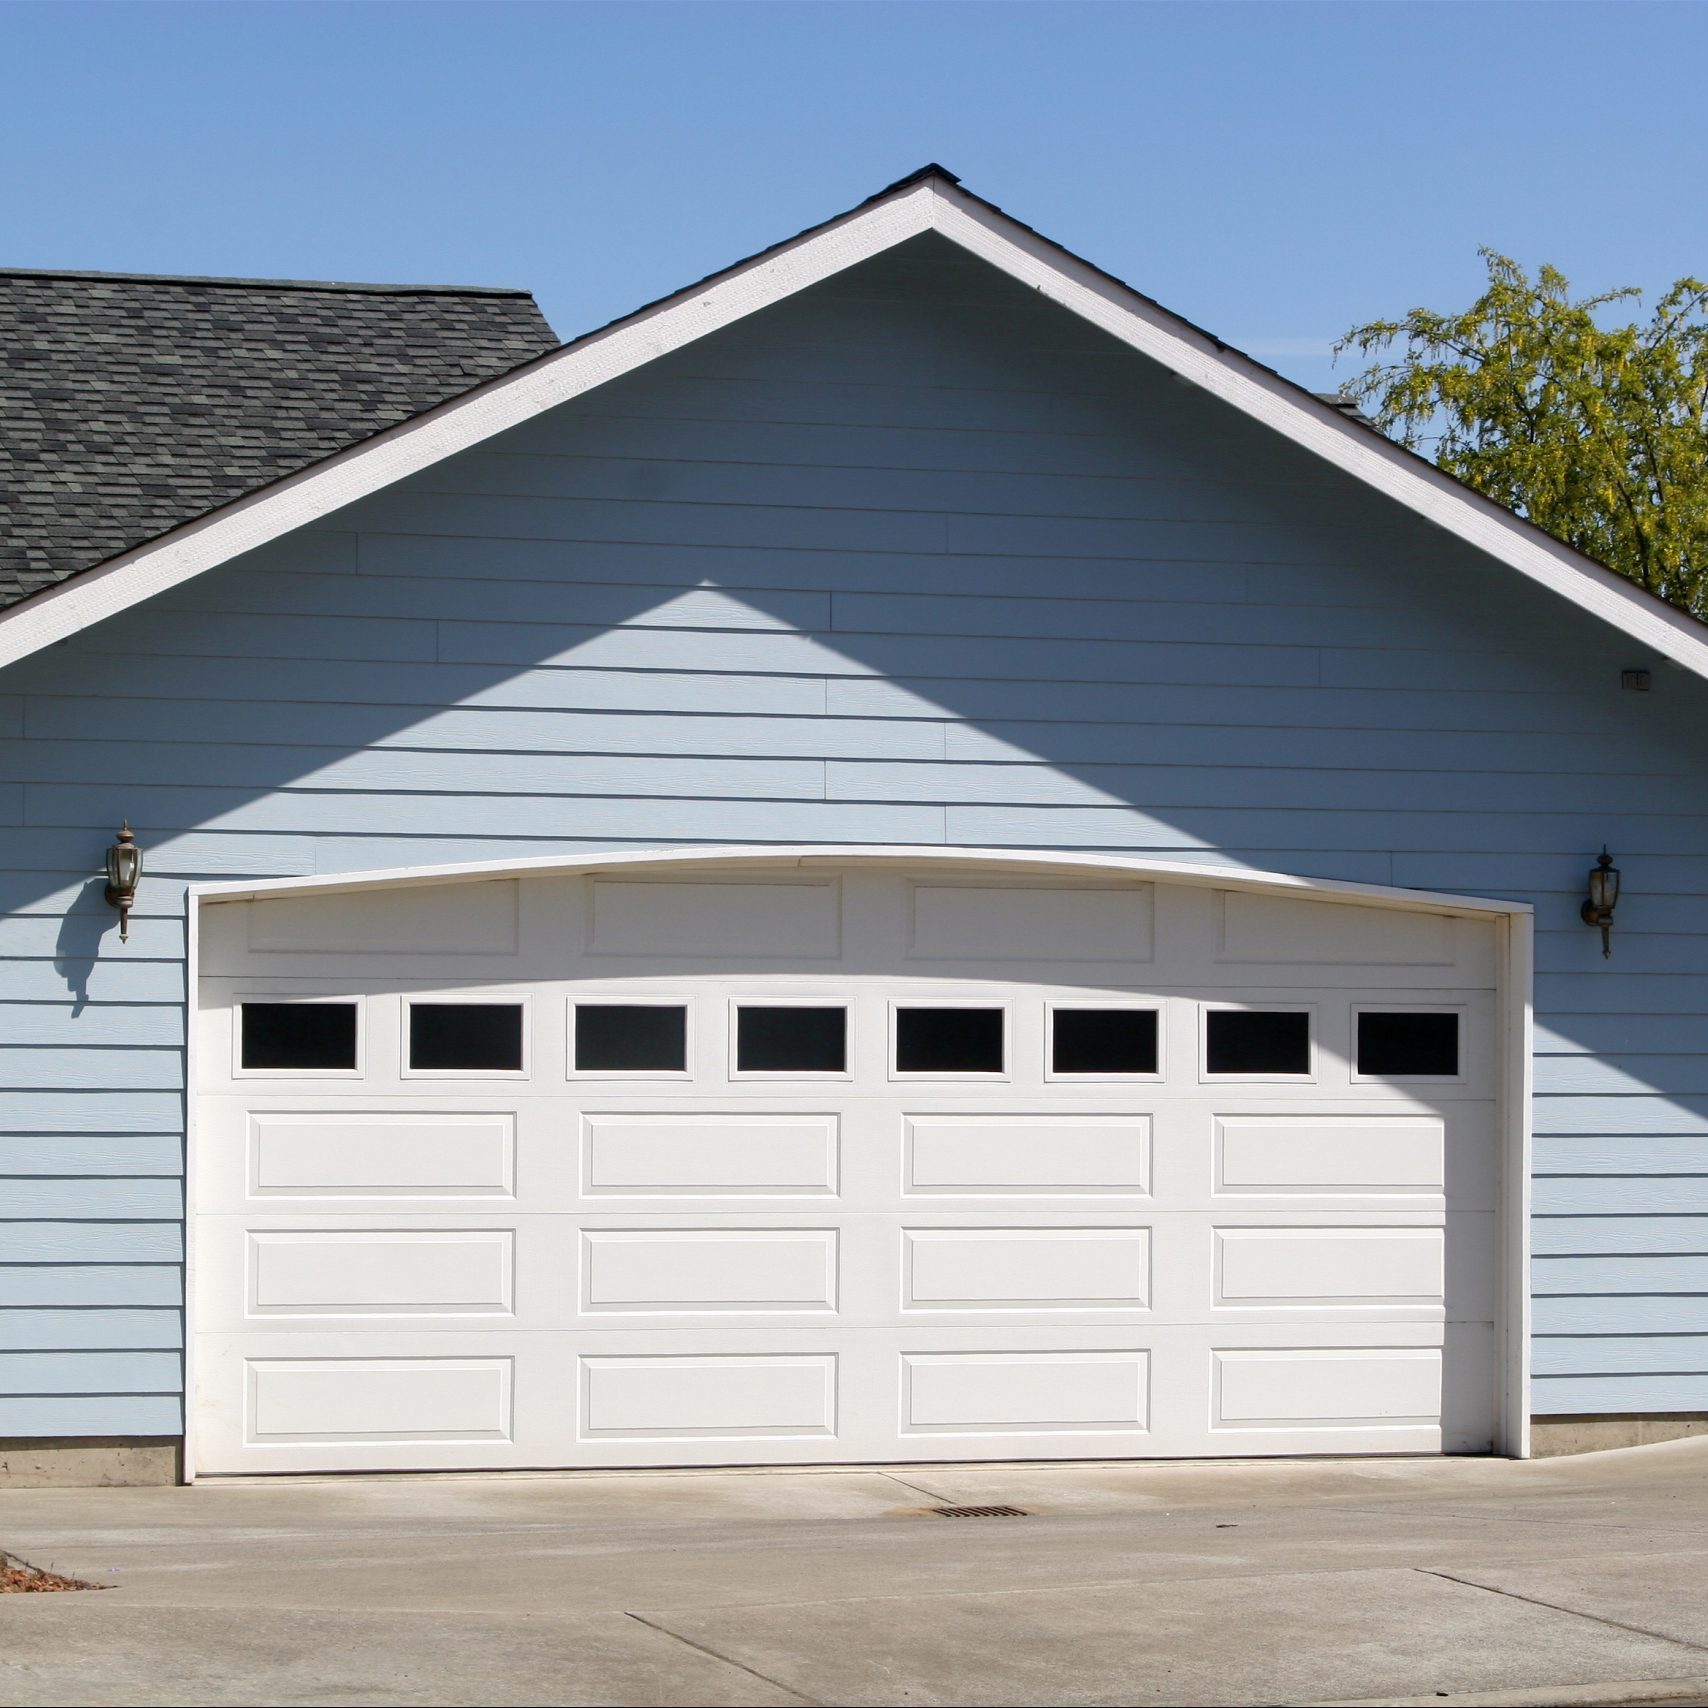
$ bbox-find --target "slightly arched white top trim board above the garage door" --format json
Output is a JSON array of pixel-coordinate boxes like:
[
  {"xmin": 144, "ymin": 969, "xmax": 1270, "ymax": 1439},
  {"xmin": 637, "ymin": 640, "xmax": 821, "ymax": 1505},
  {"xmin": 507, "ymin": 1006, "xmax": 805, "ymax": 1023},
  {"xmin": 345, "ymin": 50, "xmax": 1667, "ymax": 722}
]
[{"xmin": 188, "ymin": 842, "xmax": 1534, "ymax": 917}]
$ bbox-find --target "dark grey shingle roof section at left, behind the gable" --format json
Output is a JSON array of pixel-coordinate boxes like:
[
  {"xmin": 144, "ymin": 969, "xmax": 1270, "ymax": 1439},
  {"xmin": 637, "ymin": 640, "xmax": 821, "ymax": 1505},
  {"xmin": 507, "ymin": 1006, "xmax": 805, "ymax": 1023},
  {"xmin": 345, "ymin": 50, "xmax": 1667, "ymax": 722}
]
[{"xmin": 0, "ymin": 268, "xmax": 557, "ymax": 608}]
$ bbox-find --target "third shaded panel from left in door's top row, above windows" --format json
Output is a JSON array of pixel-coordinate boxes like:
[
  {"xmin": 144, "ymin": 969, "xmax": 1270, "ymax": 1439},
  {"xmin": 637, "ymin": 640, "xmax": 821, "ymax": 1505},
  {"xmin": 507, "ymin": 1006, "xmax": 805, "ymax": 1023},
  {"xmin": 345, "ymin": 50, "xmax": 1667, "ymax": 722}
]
[{"xmin": 909, "ymin": 883, "xmax": 1151, "ymax": 962}]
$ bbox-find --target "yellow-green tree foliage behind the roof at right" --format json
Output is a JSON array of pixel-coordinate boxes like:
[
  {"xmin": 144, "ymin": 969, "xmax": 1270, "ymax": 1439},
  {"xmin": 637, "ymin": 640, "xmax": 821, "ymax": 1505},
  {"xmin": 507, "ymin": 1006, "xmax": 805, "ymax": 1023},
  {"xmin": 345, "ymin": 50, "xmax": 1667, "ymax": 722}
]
[{"xmin": 1336, "ymin": 249, "xmax": 1708, "ymax": 617}]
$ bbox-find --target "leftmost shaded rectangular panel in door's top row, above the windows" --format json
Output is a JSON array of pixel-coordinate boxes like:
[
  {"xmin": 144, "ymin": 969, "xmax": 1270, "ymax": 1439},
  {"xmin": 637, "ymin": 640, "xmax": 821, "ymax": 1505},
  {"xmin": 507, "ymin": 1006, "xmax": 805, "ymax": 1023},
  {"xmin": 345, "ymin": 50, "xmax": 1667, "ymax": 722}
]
[{"xmin": 248, "ymin": 878, "xmax": 516, "ymax": 955}]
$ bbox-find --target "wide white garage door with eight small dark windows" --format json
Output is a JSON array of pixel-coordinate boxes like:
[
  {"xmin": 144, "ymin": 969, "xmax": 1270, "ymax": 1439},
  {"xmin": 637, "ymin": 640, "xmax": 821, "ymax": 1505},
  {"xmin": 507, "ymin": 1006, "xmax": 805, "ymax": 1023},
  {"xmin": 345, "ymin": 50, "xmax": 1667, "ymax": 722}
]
[{"xmin": 193, "ymin": 864, "xmax": 1496, "ymax": 1472}]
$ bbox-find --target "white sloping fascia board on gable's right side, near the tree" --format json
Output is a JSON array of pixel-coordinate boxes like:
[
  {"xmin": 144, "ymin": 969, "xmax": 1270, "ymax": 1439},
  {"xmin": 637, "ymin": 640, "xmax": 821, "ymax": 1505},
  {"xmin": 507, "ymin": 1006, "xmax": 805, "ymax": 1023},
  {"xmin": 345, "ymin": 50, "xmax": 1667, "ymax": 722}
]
[{"xmin": 934, "ymin": 183, "xmax": 1708, "ymax": 676}]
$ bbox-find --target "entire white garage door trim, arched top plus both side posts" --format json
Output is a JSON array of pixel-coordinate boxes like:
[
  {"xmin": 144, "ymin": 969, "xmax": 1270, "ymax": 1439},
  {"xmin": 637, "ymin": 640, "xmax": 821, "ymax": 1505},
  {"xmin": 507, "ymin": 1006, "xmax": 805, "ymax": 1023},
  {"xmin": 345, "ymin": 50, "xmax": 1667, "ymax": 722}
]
[{"xmin": 184, "ymin": 844, "xmax": 1534, "ymax": 1481}]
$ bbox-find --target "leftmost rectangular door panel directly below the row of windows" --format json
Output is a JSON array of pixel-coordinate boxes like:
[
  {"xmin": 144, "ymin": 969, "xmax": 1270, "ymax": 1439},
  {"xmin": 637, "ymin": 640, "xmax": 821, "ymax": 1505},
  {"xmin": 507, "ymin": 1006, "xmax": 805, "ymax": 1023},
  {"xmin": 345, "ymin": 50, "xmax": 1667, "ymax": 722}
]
[{"xmin": 249, "ymin": 1110, "xmax": 516, "ymax": 1197}]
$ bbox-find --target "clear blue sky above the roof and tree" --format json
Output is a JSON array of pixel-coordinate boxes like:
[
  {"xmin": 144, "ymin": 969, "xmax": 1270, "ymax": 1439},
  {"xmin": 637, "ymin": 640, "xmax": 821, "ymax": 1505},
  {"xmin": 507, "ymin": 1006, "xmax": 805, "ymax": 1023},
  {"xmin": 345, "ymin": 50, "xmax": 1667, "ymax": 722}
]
[{"xmin": 0, "ymin": 0, "xmax": 1708, "ymax": 388}]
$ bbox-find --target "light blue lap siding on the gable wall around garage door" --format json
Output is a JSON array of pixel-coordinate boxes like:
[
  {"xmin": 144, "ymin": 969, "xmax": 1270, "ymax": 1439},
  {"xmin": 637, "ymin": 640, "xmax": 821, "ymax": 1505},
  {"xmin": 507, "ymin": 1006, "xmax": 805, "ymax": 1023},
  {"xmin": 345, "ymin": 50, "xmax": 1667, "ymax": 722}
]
[{"xmin": 0, "ymin": 227, "xmax": 1708, "ymax": 1436}]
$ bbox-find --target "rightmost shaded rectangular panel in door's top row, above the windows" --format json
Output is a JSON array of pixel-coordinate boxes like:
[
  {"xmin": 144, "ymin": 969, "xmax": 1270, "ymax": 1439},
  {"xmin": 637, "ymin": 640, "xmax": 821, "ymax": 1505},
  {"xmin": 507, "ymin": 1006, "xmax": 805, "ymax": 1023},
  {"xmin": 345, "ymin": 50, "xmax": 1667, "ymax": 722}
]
[{"xmin": 1216, "ymin": 890, "xmax": 1454, "ymax": 967}]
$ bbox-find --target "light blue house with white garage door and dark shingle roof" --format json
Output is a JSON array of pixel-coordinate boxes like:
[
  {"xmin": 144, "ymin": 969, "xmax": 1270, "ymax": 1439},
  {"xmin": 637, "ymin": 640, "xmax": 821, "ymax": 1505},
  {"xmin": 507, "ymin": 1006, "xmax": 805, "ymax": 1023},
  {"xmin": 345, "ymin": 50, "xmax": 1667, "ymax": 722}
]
[{"xmin": 0, "ymin": 167, "xmax": 1708, "ymax": 1479}]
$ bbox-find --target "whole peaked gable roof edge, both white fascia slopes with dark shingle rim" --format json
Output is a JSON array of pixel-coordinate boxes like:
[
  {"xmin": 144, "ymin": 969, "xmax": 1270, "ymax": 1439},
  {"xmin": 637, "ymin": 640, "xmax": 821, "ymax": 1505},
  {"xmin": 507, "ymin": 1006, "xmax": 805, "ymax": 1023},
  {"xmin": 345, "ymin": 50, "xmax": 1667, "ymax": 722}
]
[{"xmin": 0, "ymin": 166, "xmax": 1708, "ymax": 678}]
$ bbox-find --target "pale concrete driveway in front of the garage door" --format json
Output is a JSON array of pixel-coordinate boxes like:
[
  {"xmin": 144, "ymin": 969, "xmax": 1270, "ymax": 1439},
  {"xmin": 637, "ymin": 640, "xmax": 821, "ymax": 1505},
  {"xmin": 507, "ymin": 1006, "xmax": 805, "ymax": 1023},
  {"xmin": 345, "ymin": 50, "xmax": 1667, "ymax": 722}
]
[{"xmin": 0, "ymin": 1440, "xmax": 1708, "ymax": 1705}]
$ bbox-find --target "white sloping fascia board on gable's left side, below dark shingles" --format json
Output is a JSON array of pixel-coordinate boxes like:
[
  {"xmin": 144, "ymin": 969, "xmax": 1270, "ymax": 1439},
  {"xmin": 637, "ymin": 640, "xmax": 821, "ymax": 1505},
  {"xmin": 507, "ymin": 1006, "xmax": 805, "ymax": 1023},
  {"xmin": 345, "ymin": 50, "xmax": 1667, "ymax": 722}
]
[{"xmin": 0, "ymin": 183, "xmax": 931, "ymax": 666}]
